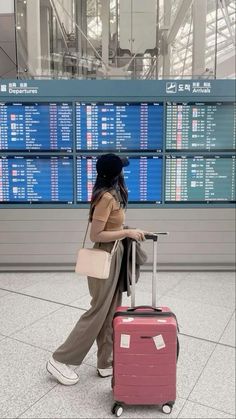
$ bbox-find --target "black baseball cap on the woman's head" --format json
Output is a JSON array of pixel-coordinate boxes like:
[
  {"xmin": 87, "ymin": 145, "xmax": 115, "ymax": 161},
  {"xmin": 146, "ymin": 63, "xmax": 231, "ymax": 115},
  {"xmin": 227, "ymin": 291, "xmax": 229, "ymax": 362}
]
[{"xmin": 96, "ymin": 153, "xmax": 129, "ymax": 179}]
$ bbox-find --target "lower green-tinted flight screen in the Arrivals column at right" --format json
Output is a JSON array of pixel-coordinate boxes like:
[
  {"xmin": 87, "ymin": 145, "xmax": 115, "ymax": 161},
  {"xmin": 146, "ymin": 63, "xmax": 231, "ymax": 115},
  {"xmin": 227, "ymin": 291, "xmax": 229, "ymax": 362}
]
[{"xmin": 165, "ymin": 155, "xmax": 236, "ymax": 203}]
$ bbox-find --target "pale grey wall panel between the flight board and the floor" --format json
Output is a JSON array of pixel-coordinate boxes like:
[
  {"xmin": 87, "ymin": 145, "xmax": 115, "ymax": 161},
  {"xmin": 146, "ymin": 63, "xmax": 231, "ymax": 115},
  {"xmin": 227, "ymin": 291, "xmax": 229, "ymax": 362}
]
[{"xmin": 0, "ymin": 208, "xmax": 235, "ymax": 270}]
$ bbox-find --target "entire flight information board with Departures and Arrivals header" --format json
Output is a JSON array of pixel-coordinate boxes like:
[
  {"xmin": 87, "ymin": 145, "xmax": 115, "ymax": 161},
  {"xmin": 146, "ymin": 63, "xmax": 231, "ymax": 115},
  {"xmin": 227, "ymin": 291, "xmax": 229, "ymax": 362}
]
[{"xmin": 0, "ymin": 79, "xmax": 236, "ymax": 208}]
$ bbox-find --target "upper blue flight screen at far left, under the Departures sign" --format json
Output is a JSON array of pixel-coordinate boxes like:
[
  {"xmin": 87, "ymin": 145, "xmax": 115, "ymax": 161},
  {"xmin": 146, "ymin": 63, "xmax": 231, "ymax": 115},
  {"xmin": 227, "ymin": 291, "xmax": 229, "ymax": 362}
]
[{"xmin": 0, "ymin": 103, "xmax": 73, "ymax": 151}]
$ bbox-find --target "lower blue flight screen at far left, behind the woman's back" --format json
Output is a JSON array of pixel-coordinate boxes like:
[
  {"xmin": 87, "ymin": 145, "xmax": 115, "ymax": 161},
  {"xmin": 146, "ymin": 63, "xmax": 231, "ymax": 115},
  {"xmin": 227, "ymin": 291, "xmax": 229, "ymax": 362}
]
[{"xmin": 0, "ymin": 156, "xmax": 73, "ymax": 204}]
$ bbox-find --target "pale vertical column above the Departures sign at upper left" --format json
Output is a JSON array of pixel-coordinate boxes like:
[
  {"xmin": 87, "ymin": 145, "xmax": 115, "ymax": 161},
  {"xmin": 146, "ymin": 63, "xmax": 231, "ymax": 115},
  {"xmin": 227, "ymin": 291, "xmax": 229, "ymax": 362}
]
[{"xmin": 26, "ymin": 0, "xmax": 41, "ymax": 76}]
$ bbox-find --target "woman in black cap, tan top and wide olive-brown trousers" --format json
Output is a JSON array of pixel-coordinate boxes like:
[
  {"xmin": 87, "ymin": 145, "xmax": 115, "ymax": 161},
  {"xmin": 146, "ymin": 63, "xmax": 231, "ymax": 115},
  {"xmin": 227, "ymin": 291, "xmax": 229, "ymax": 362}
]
[{"xmin": 47, "ymin": 154, "xmax": 144, "ymax": 385}]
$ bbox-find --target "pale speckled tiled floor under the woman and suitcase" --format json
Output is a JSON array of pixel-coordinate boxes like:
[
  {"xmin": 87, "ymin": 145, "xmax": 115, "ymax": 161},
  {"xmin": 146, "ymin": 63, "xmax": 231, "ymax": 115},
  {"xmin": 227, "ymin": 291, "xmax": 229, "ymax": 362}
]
[{"xmin": 0, "ymin": 272, "xmax": 235, "ymax": 419}]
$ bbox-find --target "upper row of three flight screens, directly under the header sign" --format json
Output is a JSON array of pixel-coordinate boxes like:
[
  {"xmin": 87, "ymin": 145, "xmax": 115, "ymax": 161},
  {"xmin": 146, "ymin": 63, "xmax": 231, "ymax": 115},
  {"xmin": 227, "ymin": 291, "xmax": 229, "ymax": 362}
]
[{"xmin": 0, "ymin": 102, "xmax": 236, "ymax": 153}]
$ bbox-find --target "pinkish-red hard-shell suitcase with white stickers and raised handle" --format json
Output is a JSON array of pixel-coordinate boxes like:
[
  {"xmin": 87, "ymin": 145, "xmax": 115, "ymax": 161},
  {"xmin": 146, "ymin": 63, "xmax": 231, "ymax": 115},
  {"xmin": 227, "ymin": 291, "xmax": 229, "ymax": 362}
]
[{"xmin": 112, "ymin": 233, "xmax": 178, "ymax": 417}]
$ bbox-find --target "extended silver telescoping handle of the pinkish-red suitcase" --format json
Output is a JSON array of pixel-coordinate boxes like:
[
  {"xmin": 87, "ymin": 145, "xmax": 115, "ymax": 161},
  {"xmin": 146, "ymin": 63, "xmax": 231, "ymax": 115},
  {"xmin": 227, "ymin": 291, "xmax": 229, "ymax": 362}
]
[{"xmin": 131, "ymin": 232, "xmax": 169, "ymax": 308}]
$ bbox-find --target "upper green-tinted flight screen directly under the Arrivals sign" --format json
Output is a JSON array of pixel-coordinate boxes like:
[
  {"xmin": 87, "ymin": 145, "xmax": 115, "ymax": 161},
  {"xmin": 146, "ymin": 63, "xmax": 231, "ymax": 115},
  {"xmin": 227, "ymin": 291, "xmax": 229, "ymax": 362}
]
[{"xmin": 166, "ymin": 102, "xmax": 236, "ymax": 151}]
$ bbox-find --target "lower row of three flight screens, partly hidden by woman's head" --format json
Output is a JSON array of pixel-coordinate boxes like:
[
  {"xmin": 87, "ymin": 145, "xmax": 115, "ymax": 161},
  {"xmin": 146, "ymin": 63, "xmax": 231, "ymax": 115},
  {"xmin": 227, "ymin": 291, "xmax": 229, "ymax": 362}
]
[{"xmin": 0, "ymin": 155, "xmax": 236, "ymax": 204}]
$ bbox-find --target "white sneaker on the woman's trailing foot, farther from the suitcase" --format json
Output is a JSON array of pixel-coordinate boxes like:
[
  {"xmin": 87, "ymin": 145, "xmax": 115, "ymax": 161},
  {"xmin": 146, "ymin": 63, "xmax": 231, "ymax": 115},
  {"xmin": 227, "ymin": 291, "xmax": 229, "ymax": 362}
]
[{"xmin": 46, "ymin": 356, "xmax": 79, "ymax": 386}]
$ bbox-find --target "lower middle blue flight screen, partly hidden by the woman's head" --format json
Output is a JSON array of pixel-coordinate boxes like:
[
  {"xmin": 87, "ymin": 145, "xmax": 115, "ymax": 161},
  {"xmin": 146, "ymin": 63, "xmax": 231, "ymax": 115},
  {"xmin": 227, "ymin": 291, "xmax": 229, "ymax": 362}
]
[{"xmin": 77, "ymin": 156, "xmax": 162, "ymax": 204}]
